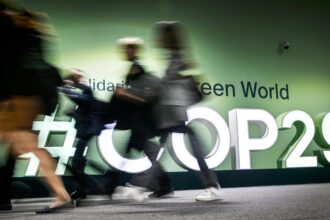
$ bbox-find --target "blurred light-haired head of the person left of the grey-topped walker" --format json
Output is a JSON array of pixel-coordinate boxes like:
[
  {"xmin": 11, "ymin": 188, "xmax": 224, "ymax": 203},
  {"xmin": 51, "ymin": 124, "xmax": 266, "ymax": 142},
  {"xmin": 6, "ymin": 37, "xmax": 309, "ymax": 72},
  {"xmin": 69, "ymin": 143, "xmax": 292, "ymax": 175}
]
[{"xmin": 118, "ymin": 37, "xmax": 143, "ymax": 61}]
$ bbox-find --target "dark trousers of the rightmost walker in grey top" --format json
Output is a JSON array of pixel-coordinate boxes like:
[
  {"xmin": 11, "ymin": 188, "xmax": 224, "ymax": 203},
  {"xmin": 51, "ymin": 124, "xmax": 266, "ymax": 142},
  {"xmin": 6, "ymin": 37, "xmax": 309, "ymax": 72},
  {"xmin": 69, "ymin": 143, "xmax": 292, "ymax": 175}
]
[{"xmin": 160, "ymin": 125, "xmax": 219, "ymax": 188}]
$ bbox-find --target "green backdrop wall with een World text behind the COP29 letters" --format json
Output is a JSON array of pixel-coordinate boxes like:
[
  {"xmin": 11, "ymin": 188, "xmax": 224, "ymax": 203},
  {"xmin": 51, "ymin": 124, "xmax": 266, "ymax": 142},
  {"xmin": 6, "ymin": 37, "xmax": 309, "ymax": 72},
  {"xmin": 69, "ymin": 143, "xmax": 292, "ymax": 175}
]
[{"xmin": 2, "ymin": 0, "xmax": 330, "ymax": 183}]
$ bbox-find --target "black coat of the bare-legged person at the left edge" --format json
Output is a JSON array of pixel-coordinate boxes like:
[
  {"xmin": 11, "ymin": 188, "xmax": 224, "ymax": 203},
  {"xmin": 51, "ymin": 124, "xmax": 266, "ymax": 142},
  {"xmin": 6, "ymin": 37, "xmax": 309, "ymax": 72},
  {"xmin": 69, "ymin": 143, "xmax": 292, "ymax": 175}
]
[{"xmin": 0, "ymin": 13, "xmax": 62, "ymax": 115}]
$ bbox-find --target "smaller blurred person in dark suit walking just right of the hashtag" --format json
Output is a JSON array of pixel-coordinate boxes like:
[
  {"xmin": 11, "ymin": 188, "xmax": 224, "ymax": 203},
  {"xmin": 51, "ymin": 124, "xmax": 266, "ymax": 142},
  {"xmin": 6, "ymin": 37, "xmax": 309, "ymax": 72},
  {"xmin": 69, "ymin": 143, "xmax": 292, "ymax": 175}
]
[{"xmin": 59, "ymin": 69, "xmax": 113, "ymax": 200}]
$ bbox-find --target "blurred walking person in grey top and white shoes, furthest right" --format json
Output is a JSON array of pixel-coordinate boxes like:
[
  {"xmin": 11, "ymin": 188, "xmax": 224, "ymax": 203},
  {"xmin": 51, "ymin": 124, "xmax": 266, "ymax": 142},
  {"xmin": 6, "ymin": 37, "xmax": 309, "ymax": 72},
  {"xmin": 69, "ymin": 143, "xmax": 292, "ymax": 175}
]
[{"xmin": 155, "ymin": 21, "xmax": 221, "ymax": 201}]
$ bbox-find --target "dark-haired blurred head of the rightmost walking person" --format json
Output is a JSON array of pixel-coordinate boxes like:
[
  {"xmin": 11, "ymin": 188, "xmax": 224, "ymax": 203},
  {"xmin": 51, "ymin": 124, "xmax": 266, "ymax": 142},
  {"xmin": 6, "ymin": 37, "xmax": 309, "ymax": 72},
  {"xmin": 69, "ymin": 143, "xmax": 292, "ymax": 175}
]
[{"xmin": 154, "ymin": 21, "xmax": 186, "ymax": 50}]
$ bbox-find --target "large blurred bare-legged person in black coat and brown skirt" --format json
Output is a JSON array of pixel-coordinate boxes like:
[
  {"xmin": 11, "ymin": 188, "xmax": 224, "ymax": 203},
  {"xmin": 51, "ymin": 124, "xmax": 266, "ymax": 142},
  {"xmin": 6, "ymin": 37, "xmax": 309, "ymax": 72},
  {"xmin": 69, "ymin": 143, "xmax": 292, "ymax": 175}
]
[{"xmin": 0, "ymin": 2, "xmax": 71, "ymax": 213}]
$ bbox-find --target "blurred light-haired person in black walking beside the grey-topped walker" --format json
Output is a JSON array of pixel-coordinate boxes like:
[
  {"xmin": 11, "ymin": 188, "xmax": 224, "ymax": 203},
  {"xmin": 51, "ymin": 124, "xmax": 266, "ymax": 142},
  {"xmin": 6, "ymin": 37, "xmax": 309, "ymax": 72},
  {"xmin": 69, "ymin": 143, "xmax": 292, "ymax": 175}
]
[{"xmin": 110, "ymin": 37, "xmax": 173, "ymax": 200}]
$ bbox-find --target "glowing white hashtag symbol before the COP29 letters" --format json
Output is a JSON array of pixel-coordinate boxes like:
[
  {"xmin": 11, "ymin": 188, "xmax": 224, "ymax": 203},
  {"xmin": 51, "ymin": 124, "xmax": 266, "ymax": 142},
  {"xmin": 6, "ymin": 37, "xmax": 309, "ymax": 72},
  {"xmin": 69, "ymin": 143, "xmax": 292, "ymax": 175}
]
[{"xmin": 20, "ymin": 107, "xmax": 78, "ymax": 176}]
